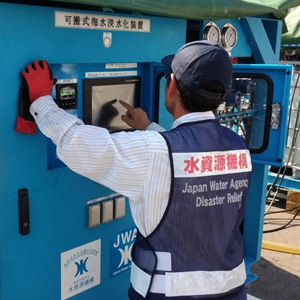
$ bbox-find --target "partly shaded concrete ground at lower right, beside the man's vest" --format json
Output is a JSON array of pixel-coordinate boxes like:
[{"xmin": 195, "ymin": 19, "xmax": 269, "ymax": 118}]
[{"xmin": 248, "ymin": 200, "xmax": 300, "ymax": 300}]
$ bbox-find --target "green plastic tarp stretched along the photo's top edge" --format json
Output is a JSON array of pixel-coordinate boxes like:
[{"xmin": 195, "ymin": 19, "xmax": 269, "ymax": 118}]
[{"xmin": 50, "ymin": 0, "xmax": 300, "ymax": 20}]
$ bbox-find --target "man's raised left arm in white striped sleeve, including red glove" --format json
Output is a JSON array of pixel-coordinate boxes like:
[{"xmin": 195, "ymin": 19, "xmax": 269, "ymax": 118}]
[{"xmin": 22, "ymin": 61, "xmax": 150, "ymax": 201}]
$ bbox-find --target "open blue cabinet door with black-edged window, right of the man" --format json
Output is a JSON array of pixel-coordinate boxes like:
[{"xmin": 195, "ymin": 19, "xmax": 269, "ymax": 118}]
[{"xmin": 224, "ymin": 64, "xmax": 292, "ymax": 166}]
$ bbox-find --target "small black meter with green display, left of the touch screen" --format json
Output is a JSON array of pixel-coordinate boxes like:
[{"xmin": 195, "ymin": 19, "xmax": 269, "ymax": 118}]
[{"xmin": 56, "ymin": 83, "xmax": 77, "ymax": 109}]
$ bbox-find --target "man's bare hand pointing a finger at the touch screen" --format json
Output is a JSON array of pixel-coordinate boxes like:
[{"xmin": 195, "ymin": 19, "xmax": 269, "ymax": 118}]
[{"xmin": 119, "ymin": 100, "xmax": 151, "ymax": 130}]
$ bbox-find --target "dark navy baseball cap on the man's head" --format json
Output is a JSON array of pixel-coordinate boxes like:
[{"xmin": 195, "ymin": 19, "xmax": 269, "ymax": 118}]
[{"xmin": 162, "ymin": 41, "xmax": 232, "ymax": 100}]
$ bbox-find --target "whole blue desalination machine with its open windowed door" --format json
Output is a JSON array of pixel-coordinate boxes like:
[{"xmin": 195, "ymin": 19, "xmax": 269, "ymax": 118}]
[{"xmin": 0, "ymin": 3, "xmax": 291, "ymax": 300}]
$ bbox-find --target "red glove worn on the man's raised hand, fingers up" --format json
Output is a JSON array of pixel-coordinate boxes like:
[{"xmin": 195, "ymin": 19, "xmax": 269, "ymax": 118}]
[{"xmin": 22, "ymin": 60, "xmax": 54, "ymax": 102}]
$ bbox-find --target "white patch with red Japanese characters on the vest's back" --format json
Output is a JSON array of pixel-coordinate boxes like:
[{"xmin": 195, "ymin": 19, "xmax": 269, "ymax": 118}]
[{"xmin": 173, "ymin": 150, "xmax": 252, "ymax": 177}]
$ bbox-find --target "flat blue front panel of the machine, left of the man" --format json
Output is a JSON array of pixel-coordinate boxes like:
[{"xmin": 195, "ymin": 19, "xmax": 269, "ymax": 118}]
[{"xmin": 0, "ymin": 3, "xmax": 186, "ymax": 300}]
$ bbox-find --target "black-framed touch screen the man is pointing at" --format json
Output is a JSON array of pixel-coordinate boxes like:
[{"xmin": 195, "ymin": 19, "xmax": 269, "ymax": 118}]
[{"xmin": 84, "ymin": 77, "xmax": 140, "ymax": 132}]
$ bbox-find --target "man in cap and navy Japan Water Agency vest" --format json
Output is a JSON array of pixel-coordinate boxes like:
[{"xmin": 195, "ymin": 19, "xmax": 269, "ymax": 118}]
[{"xmin": 22, "ymin": 41, "xmax": 251, "ymax": 300}]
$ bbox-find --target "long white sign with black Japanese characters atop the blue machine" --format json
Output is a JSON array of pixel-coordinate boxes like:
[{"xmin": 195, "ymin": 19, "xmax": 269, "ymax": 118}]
[{"xmin": 55, "ymin": 11, "xmax": 150, "ymax": 33}]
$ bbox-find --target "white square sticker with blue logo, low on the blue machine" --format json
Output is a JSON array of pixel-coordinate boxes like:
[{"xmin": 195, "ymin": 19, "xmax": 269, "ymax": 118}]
[{"xmin": 61, "ymin": 240, "xmax": 101, "ymax": 300}]
